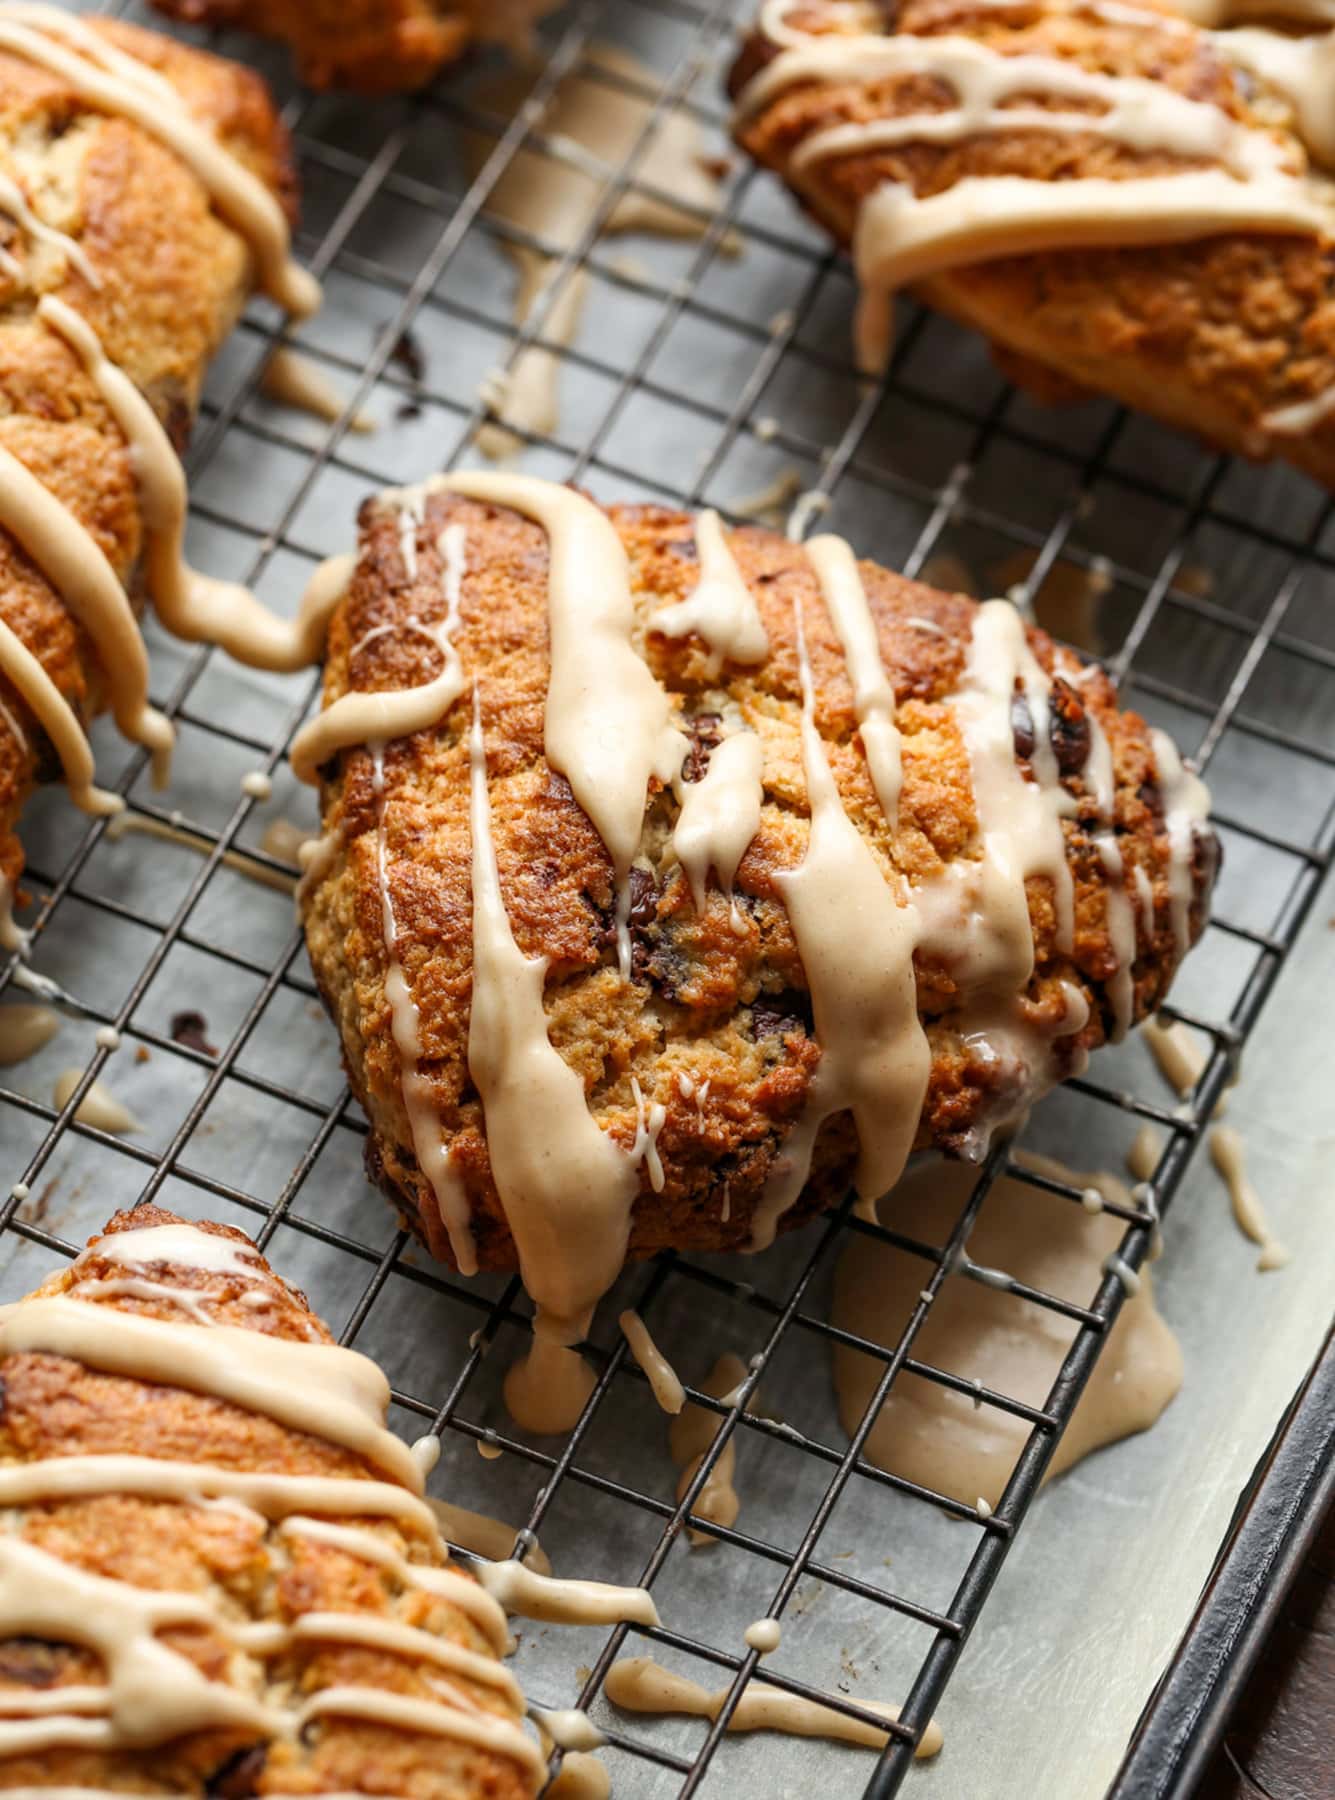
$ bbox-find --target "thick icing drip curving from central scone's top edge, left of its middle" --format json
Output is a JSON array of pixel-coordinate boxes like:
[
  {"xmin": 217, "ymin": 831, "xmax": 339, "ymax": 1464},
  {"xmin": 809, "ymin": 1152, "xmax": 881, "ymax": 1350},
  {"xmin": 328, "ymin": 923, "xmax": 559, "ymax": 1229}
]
[{"xmin": 439, "ymin": 473, "xmax": 689, "ymax": 977}]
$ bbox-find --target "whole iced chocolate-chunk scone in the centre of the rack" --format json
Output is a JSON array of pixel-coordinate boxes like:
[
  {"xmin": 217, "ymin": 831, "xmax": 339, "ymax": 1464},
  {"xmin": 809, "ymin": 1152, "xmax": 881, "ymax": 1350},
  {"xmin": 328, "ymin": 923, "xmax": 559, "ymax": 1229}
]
[{"xmin": 293, "ymin": 473, "xmax": 1216, "ymax": 1341}]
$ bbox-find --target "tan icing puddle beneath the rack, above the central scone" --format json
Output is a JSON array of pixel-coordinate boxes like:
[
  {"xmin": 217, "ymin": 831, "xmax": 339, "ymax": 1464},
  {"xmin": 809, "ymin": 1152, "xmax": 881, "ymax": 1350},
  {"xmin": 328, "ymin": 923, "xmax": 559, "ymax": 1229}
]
[{"xmin": 468, "ymin": 43, "xmax": 736, "ymax": 461}]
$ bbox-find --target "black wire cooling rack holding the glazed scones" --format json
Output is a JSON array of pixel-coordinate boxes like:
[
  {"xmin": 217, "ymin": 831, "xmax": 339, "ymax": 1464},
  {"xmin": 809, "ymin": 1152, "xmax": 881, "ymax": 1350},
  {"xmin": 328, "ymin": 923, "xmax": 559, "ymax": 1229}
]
[{"xmin": 0, "ymin": 0, "xmax": 1335, "ymax": 1796}]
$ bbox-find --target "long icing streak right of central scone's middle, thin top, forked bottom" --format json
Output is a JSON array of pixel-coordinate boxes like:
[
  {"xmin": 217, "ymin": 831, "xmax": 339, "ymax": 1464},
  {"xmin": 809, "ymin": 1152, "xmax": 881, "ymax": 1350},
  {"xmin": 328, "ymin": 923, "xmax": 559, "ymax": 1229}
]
[{"xmin": 752, "ymin": 583, "xmax": 932, "ymax": 1249}]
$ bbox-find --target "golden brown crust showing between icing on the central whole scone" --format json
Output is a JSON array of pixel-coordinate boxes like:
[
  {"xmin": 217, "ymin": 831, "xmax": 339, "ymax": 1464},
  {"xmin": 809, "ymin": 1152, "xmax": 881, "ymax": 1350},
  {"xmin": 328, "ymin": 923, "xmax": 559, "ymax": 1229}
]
[{"xmin": 304, "ymin": 490, "xmax": 1213, "ymax": 1267}]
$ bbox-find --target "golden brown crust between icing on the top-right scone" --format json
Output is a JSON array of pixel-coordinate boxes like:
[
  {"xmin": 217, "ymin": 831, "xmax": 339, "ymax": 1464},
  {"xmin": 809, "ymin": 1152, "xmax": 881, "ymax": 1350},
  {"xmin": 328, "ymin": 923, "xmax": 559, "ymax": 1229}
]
[{"xmin": 730, "ymin": 0, "xmax": 1335, "ymax": 486}]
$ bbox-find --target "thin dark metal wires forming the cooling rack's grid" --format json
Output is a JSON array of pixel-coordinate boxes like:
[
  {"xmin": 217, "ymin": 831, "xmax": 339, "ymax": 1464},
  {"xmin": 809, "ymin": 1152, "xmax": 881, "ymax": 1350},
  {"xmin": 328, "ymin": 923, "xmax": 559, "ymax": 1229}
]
[{"xmin": 0, "ymin": 0, "xmax": 1335, "ymax": 1800}]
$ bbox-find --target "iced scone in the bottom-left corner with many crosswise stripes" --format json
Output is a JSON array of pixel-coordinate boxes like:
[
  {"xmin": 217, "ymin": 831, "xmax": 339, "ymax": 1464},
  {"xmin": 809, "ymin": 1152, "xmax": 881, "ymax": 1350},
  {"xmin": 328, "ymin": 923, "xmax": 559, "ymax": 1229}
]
[{"xmin": 0, "ymin": 1206, "xmax": 545, "ymax": 1800}]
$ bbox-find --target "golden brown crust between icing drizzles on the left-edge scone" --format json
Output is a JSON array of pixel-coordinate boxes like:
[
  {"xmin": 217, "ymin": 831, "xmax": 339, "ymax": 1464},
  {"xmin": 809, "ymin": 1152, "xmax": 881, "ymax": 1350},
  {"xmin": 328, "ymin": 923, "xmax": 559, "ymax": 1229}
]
[{"xmin": 0, "ymin": 20, "xmax": 295, "ymax": 921}]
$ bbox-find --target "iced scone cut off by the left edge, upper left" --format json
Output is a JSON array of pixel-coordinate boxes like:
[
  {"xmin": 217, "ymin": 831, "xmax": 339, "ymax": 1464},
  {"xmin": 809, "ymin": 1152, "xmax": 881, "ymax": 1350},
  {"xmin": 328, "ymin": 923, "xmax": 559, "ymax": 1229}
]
[{"xmin": 0, "ymin": 5, "xmax": 318, "ymax": 949}]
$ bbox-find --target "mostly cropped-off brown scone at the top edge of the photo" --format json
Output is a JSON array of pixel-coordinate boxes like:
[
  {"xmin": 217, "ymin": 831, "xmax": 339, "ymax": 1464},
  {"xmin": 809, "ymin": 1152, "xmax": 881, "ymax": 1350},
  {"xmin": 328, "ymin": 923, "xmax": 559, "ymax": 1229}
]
[{"xmin": 153, "ymin": 0, "xmax": 556, "ymax": 94}]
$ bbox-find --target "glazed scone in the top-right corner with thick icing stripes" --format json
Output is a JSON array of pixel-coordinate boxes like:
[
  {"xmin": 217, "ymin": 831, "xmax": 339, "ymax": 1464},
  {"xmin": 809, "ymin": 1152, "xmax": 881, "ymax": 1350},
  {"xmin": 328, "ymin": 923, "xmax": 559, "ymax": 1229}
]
[{"xmin": 730, "ymin": 0, "xmax": 1335, "ymax": 486}]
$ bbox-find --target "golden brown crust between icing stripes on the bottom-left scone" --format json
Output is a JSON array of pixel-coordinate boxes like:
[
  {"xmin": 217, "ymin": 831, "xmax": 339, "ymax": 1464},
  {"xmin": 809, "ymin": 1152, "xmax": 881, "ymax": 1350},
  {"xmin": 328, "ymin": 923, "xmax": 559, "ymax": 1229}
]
[{"xmin": 0, "ymin": 1206, "xmax": 533, "ymax": 1800}]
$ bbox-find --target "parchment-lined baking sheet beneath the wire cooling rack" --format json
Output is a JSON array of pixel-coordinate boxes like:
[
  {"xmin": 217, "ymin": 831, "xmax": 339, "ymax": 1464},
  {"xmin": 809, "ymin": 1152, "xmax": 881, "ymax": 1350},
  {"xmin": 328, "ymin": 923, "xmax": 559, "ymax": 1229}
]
[{"xmin": 0, "ymin": 4, "xmax": 1335, "ymax": 1800}]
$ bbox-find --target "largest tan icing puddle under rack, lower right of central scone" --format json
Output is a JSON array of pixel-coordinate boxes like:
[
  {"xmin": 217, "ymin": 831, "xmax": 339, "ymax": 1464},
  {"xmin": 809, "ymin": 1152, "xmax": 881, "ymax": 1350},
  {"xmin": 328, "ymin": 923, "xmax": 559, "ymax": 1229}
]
[{"xmin": 833, "ymin": 1156, "xmax": 1182, "ymax": 1507}]
